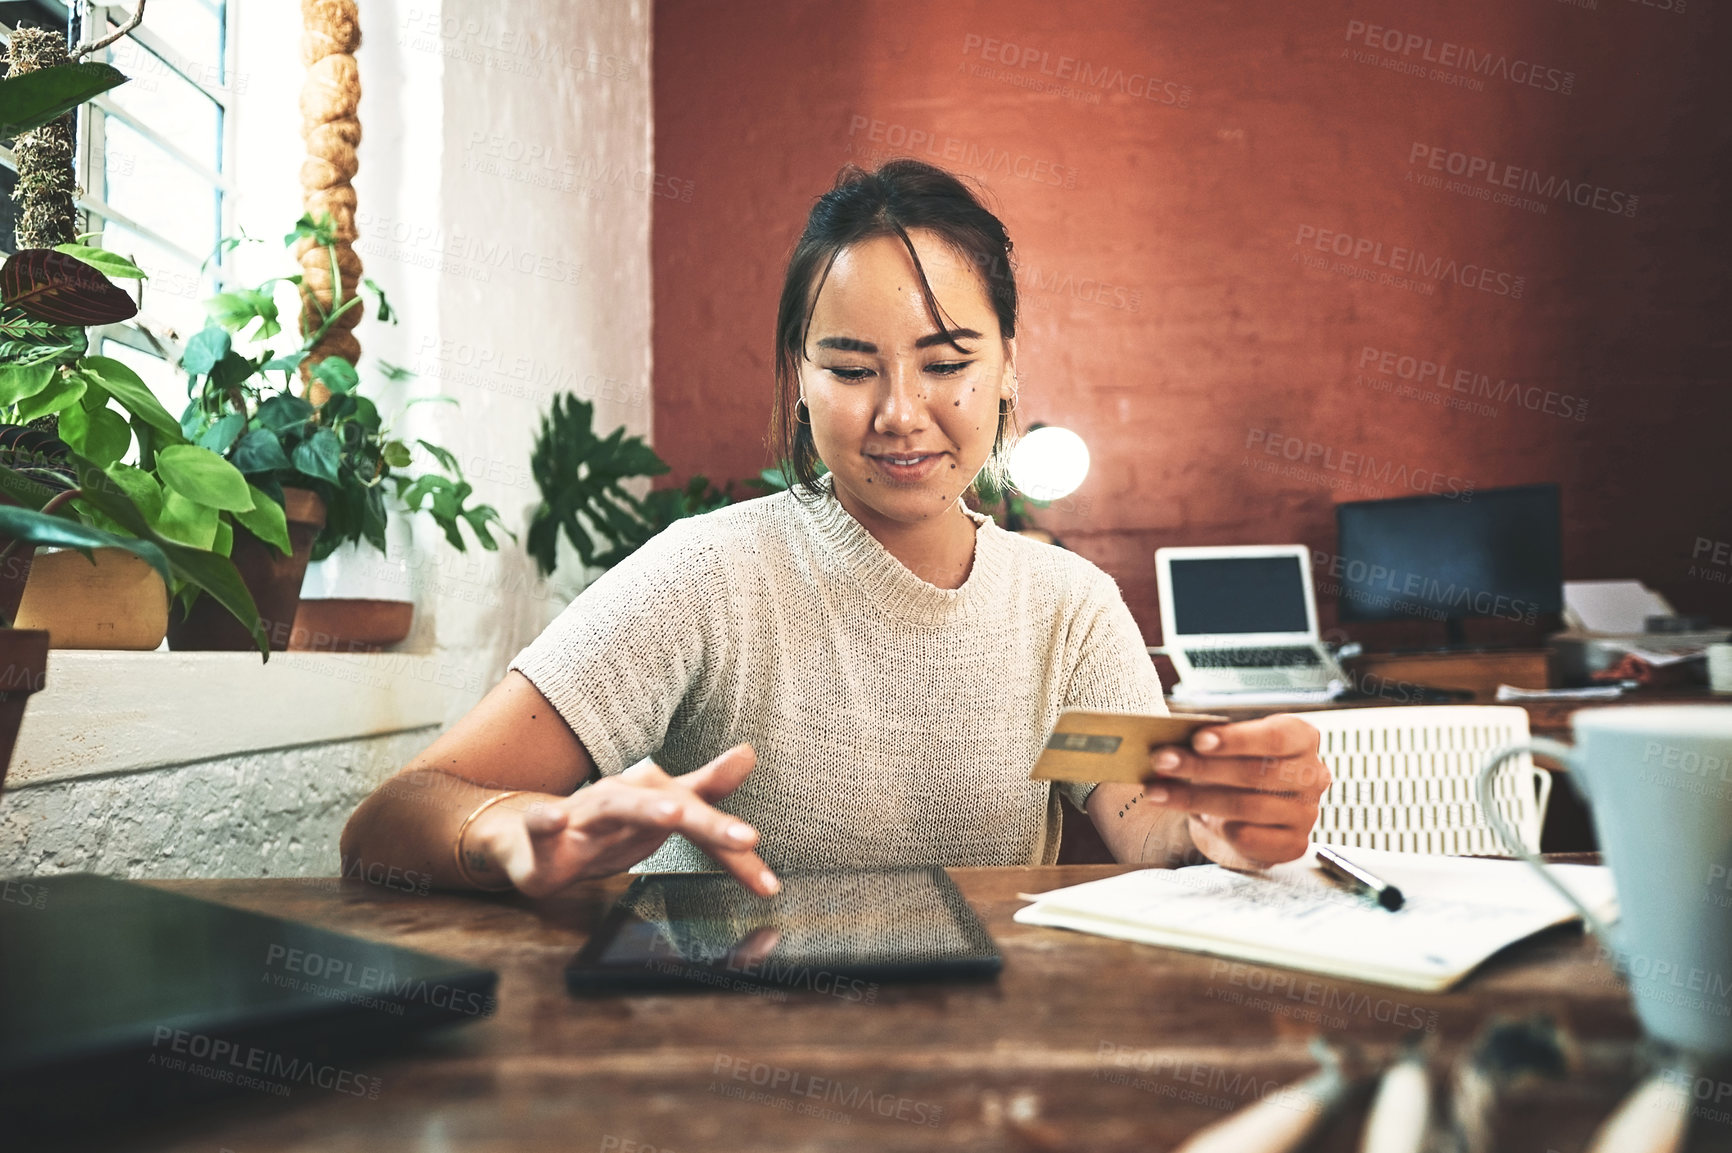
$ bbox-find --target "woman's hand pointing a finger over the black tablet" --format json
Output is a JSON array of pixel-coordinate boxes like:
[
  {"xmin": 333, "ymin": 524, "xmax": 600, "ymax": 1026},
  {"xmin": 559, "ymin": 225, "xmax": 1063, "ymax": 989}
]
[{"xmin": 464, "ymin": 744, "xmax": 781, "ymax": 897}]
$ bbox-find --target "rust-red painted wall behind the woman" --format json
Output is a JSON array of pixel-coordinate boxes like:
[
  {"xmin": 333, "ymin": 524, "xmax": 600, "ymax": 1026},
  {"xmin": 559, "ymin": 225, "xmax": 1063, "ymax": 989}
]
[{"xmin": 653, "ymin": 0, "xmax": 1732, "ymax": 642}]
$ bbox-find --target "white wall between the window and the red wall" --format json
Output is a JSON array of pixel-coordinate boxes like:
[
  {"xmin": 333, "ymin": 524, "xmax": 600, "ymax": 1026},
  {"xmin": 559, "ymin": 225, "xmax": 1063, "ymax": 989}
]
[{"xmin": 237, "ymin": 0, "xmax": 653, "ymax": 718}]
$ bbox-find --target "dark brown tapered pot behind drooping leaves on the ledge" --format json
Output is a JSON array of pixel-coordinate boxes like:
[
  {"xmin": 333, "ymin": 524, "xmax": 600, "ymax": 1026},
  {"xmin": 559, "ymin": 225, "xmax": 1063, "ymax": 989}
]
[{"xmin": 168, "ymin": 488, "xmax": 324, "ymax": 653}]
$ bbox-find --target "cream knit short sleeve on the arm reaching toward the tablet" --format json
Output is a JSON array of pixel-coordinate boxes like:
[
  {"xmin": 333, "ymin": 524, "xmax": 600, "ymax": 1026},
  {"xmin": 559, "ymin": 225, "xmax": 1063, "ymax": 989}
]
[{"xmin": 511, "ymin": 518, "xmax": 727, "ymax": 776}]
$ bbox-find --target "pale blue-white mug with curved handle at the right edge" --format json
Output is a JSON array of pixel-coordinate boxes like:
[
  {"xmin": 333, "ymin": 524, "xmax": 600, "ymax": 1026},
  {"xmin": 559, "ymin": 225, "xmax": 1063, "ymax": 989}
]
[{"xmin": 1479, "ymin": 705, "xmax": 1732, "ymax": 1056}]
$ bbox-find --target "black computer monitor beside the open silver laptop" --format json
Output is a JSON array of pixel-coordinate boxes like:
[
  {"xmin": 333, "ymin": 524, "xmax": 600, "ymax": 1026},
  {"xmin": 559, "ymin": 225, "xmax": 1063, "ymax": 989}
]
[{"xmin": 1318, "ymin": 485, "xmax": 1564, "ymax": 644}]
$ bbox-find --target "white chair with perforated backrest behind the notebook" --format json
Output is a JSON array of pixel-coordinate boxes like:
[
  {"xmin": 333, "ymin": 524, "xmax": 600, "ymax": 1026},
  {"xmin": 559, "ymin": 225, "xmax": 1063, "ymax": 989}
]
[{"xmin": 1299, "ymin": 705, "xmax": 1552, "ymax": 857}]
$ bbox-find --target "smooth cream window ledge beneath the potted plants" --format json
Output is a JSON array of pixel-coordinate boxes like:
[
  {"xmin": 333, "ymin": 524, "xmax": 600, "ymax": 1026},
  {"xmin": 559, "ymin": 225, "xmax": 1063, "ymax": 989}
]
[{"xmin": 5, "ymin": 649, "xmax": 462, "ymax": 793}]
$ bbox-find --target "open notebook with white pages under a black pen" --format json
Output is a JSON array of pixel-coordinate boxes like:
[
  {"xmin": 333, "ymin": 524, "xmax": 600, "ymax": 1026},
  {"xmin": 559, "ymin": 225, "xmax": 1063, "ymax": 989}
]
[{"xmin": 1017, "ymin": 848, "xmax": 1618, "ymax": 992}]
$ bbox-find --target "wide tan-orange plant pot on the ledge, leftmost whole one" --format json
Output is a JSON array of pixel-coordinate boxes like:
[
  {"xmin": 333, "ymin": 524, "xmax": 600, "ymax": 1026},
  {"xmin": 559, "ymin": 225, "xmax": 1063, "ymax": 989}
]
[{"xmin": 16, "ymin": 549, "xmax": 168, "ymax": 651}]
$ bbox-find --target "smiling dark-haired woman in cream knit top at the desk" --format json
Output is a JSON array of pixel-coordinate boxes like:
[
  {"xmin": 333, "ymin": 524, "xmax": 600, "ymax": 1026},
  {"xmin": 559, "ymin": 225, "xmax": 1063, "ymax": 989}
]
[{"xmin": 343, "ymin": 161, "xmax": 1328, "ymax": 895}]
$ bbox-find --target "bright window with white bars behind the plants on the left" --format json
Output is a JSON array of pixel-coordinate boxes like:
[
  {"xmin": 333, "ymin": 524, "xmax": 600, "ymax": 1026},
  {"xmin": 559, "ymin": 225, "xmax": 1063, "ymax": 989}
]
[{"xmin": 0, "ymin": 0, "xmax": 236, "ymax": 414}]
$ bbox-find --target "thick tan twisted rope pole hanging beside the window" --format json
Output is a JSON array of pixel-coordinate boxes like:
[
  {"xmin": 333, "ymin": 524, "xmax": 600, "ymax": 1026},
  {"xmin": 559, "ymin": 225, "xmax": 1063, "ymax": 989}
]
[{"xmin": 294, "ymin": 0, "xmax": 364, "ymax": 403}]
